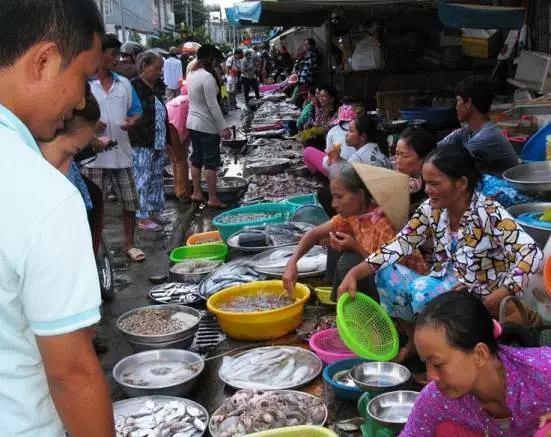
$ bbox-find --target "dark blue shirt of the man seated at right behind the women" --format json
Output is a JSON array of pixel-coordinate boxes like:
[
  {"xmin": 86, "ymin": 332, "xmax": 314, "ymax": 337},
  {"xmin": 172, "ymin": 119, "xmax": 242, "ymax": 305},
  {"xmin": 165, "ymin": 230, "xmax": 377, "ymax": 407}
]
[{"xmin": 438, "ymin": 121, "xmax": 518, "ymax": 176}]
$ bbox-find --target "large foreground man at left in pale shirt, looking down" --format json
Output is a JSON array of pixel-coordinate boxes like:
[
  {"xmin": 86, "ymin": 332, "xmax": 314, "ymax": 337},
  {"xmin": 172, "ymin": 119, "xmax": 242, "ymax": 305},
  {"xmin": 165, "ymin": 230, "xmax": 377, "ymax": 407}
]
[{"xmin": 0, "ymin": 0, "xmax": 114, "ymax": 437}]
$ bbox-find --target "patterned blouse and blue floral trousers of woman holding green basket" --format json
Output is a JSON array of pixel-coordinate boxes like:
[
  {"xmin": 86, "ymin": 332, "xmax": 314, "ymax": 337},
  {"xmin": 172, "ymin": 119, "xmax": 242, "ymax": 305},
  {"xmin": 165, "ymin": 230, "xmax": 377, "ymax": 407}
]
[{"xmin": 365, "ymin": 193, "xmax": 543, "ymax": 320}]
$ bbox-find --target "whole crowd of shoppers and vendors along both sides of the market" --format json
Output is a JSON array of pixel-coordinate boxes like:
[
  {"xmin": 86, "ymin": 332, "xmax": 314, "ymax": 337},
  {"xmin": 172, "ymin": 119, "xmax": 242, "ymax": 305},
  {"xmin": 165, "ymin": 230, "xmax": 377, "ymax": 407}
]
[{"xmin": 0, "ymin": 0, "xmax": 551, "ymax": 437}]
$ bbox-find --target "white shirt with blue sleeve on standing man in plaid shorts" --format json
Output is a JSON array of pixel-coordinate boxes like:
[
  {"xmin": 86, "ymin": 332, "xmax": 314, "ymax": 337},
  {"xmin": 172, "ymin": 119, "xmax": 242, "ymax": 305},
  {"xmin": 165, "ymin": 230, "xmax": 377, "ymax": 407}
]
[{"xmin": 86, "ymin": 73, "xmax": 143, "ymax": 169}]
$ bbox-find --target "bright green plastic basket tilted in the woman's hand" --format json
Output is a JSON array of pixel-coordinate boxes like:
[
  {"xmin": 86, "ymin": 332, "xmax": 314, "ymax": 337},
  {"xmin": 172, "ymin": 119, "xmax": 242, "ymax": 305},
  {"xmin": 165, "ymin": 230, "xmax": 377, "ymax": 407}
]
[{"xmin": 337, "ymin": 293, "xmax": 400, "ymax": 361}]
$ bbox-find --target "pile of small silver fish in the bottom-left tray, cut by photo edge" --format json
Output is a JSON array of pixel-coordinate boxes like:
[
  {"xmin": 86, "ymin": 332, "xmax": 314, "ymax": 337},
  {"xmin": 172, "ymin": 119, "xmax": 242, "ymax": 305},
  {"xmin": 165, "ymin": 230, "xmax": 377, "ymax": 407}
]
[{"xmin": 115, "ymin": 400, "xmax": 208, "ymax": 437}]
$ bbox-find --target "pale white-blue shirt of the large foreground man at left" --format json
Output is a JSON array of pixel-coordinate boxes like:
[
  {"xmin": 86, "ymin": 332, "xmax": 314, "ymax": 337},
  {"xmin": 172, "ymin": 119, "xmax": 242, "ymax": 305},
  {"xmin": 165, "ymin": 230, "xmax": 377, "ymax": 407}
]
[{"xmin": 0, "ymin": 105, "xmax": 101, "ymax": 437}]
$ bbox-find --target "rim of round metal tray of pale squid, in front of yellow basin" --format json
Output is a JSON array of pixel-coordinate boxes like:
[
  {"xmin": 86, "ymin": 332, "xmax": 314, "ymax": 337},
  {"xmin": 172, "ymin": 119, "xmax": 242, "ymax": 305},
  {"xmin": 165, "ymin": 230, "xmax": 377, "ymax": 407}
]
[{"xmin": 218, "ymin": 346, "xmax": 323, "ymax": 390}]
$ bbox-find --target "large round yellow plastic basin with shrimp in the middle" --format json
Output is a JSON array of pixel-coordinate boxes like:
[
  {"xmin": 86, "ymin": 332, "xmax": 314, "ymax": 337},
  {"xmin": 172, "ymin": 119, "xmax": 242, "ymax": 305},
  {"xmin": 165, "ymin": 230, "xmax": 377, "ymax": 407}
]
[{"xmin": 207, "ymin": 280, "xmax": 310, "ymax": 341}]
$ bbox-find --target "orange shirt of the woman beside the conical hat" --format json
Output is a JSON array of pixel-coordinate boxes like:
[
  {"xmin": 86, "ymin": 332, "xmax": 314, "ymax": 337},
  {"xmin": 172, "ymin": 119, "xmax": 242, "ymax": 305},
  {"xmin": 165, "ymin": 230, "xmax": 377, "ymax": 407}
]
[{"xmin": 331, "ymin": 208, "xmax": 428, "ymax": 275}]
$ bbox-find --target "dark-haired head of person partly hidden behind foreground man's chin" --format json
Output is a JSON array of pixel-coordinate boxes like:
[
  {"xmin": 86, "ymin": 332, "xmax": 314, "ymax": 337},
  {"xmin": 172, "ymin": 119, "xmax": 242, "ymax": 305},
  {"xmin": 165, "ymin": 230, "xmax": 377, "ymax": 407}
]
[{"xmin": 40, "ymin": 85, "xmax": 101, "ymax": 173}]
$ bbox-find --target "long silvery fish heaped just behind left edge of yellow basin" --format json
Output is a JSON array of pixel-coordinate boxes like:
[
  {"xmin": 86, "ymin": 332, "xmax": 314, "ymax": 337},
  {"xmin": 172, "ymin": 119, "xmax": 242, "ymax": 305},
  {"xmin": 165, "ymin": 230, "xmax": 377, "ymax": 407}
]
[{"xmin": 199, "ymin": 258, "xmax": 268, "ymax": 299}]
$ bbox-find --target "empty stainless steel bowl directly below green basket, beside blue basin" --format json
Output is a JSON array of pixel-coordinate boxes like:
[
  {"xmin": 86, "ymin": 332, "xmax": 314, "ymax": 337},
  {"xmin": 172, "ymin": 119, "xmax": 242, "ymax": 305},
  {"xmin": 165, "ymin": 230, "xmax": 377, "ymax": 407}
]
[{"xmin": 350, "ymin": 361, "xmax": 411, "ymax": 393}]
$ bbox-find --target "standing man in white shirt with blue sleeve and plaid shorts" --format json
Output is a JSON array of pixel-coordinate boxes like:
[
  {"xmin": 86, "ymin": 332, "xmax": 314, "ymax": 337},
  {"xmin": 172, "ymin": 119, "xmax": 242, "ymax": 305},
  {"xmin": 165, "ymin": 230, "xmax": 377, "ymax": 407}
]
[{"xmin": 82, "ymin": 34, "xmax": 145, "ymax": 262}]
